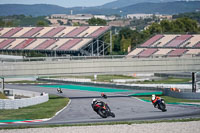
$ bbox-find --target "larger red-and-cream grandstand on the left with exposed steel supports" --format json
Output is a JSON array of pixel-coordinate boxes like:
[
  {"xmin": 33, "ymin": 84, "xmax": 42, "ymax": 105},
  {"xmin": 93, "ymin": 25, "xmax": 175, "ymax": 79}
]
[{"xmin": 0, "ymin": 26, "xmax": 110, "ymax": 56}]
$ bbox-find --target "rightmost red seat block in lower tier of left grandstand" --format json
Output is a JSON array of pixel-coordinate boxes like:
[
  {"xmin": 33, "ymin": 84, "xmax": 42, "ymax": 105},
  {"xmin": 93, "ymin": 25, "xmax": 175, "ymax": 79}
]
[{"xmin": 57, "ymin": 39, "xmax": 82, "ymax": 50}]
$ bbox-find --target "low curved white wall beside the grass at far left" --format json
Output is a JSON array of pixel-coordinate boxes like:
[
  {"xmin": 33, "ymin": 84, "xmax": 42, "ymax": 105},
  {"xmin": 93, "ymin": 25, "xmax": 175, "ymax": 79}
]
[{"xmin": 0, "ymin": 90, "xmax": 49, "ymax": 109}]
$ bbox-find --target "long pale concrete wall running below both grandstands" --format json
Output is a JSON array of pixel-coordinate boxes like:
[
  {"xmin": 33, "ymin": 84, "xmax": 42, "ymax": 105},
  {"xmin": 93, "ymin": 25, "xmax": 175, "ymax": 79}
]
[{"xmin": 0, "ymin": 57, "xmax": 200, "ymax": 76}]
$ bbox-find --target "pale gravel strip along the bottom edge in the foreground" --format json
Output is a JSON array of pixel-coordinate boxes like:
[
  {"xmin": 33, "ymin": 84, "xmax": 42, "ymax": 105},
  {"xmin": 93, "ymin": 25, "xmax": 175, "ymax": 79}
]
[{"xmin": 0, "ymin": 121, "xmax": 200, "ymax": 133}]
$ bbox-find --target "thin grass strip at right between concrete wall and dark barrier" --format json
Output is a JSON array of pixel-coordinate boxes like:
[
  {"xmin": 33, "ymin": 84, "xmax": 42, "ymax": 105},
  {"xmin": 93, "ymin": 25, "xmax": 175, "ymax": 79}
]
[{"xmin": 137, "ymin": 78, "xmax": 191, "ymax": 84}]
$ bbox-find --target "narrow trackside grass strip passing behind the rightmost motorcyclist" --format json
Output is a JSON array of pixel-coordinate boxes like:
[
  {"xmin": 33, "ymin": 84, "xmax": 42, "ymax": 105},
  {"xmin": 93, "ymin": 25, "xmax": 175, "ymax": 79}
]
[{"xmin": 138, "ymin": 96, "xmax": 200, "ymax": 103}]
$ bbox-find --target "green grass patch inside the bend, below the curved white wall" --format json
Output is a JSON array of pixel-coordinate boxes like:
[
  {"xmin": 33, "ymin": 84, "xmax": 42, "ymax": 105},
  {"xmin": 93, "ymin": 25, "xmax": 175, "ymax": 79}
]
[{"xmin": 0, "ymin": 95, "xmax": 69, "ymax": 120}]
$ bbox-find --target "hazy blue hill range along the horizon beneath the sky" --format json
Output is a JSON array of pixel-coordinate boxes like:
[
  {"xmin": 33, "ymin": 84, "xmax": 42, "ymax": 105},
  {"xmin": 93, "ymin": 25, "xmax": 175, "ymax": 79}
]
[{"xmin": 0, "ymin": 0, "xmax": 200, "ymax": 16}]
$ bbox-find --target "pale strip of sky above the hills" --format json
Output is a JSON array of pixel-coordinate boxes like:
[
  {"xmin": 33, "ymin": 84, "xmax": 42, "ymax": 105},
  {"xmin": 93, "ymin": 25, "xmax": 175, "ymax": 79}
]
[{"xmin": 0, "ymin": 0, "xmax": 116, "ymax": 7}]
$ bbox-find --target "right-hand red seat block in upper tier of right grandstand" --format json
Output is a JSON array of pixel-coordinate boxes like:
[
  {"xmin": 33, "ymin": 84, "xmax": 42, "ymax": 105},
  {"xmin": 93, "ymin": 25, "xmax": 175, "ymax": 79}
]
[{"xmin": 165, "ymin": 35, "xmax": 192, "ymax": 47}]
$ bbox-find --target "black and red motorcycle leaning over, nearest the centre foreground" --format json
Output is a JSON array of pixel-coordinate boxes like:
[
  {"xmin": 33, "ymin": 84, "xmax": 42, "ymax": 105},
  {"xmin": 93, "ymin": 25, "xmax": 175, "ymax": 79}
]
[{"xmin": 93, "ymin": 102, "xmax": 115, "ymax": 118}]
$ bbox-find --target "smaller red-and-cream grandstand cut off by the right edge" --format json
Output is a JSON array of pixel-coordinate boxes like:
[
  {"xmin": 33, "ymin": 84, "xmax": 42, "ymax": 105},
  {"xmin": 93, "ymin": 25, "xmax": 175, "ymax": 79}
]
[{"xmin": 127, "ymin": 34, "xmax": 200, "ymax": 58}]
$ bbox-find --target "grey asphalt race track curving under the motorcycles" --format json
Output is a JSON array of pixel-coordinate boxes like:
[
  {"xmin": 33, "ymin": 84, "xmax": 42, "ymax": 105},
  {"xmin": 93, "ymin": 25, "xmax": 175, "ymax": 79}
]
[{"xmin": 0, "ymin": 85, "xmax": 200, "ymax": 126}]
